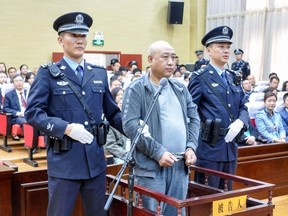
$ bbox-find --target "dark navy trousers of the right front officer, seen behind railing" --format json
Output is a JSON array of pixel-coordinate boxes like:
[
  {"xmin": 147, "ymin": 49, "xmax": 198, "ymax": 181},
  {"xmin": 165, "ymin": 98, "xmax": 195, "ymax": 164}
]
[{"xmin": 195, "ymin": 158, "xmax": 237, "ymax": 190}]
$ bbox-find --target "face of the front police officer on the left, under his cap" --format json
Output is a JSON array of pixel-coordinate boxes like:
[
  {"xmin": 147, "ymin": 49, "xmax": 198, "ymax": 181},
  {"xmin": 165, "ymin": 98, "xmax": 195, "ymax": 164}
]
[{"xmin": 58, "ymin": 32, "xmax": 87, "ymax": 62}]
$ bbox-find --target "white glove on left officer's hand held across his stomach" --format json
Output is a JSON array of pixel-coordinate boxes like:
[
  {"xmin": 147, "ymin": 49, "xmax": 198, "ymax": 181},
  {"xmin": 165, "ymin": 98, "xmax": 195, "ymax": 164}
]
[{"xmin": 67, "ymin": 123, "xmax": 94, "ymax": 144}]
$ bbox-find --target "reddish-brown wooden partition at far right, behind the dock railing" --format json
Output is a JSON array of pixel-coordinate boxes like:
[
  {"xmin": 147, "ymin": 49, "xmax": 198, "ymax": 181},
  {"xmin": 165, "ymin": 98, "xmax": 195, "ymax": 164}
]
[{"xmin": 234, "ymin": 143, "xmax": 288, "ymax": 199}]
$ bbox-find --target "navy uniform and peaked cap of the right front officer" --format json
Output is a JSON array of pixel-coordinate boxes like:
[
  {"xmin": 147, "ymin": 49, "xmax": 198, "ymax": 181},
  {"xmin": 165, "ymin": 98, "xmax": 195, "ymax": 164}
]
[{"xmin": 188, "ymin": 26, "xmax": 249, "ymax": 189}]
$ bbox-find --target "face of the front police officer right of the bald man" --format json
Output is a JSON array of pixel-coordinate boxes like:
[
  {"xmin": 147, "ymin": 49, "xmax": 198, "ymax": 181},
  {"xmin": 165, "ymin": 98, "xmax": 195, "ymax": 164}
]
[{"xmin": 206, "ymin": 43, "xmax": 230, "ymax": 68}]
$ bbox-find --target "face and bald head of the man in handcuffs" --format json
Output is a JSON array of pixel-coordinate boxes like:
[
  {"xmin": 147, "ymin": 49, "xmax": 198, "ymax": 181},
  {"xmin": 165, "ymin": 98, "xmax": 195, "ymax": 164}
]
[{"xmin": 148, "ymin": 44, "xmax": 176, "ymax": 80}]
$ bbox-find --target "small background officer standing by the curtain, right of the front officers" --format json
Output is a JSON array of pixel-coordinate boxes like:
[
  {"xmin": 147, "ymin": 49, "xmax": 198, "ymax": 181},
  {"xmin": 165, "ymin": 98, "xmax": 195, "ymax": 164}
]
[{"xmin": 231, "ymin": 48, "xmax": 250, "ymax": 80}]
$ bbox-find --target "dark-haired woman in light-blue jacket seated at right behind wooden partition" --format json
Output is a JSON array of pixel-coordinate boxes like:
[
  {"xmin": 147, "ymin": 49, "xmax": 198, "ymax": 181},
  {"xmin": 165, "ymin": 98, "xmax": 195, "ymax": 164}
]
[{"xmin": 255, "ymin": 92, "xmax": 286, "ymax": 143}]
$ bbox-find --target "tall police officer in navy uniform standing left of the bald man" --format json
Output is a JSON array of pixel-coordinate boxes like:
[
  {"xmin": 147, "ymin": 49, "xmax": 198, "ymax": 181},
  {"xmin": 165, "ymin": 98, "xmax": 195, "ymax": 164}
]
[{"xmin": 25, "ymin": 12, "xmax": 123, "ymax": 216}]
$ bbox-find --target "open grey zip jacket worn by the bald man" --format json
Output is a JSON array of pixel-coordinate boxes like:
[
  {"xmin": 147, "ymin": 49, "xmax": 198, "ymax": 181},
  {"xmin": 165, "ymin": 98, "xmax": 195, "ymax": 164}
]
[{"xmin": 122, "ymin": 74, "xmax": 200, "ymax": 177}]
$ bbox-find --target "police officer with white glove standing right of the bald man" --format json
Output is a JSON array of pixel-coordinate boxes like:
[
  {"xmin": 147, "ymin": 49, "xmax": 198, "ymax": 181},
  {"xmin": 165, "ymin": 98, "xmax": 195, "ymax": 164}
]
[{"xmin": 188, "ymin": 26, "xmax": 248, "ymax": 189}]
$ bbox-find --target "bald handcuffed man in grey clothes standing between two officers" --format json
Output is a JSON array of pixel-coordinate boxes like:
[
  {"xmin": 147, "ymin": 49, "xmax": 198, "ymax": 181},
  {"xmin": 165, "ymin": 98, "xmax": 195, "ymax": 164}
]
[{"xmin": 122, "ymin": 41, "xmax": 200, "ymax": 215}]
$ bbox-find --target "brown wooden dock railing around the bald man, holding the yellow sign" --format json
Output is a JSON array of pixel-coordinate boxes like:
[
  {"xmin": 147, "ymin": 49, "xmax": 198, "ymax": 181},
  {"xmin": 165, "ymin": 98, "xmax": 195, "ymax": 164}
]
[{"xmin": 107, "ymin": 166, "xmax": 274, "ymax": 216}]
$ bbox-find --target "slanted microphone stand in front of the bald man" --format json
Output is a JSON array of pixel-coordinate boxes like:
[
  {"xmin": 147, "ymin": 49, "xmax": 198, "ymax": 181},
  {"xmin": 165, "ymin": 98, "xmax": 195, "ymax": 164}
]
[{"xmin": 104, "ymin": 81, "xmax": 167, "ymax": 216}]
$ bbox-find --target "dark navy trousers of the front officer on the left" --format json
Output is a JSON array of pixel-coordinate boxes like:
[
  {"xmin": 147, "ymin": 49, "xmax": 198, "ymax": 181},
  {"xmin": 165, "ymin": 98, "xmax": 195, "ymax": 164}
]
[{"xmin": 47, "ymin": 172, "xmax": 107, "ymax": 216}]
